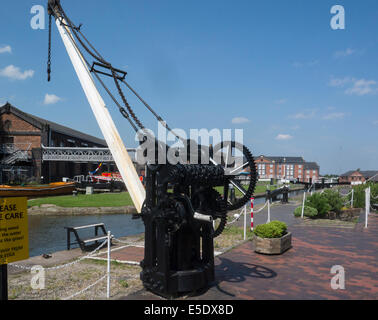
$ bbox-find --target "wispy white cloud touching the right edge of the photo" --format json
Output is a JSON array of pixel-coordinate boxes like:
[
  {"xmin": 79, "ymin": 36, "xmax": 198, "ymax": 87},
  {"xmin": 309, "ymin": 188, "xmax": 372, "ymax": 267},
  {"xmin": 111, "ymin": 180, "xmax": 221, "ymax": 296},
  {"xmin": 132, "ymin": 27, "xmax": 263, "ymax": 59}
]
[{"xmin": 329, "ymin": 77, "xmax": 378, "ymax": 96}]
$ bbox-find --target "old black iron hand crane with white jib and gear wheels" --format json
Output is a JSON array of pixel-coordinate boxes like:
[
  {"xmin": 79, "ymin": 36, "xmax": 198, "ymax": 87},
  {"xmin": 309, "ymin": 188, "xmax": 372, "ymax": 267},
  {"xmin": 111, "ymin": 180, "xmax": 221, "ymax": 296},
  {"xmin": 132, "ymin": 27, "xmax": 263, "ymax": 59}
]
[{"xmin": 47, "ymin": 0, "xmax": 257, "ymax": 297}]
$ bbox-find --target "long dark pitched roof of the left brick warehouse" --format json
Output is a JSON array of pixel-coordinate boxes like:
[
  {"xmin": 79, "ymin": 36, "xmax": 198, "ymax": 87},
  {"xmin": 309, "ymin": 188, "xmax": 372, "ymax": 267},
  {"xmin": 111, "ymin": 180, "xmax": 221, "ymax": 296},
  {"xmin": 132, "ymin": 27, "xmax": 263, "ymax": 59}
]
[{"xmin": 0, "ymin": 102, "xmax": 107, "ymax": 147}]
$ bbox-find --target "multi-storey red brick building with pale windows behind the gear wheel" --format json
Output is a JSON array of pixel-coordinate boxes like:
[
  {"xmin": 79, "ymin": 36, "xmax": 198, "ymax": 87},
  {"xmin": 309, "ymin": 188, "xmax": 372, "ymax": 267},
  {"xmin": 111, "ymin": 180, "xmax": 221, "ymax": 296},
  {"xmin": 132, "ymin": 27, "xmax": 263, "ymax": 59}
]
[{"xmin": 256, "ymin": 155, "xmax": 320, "ymax": 182}]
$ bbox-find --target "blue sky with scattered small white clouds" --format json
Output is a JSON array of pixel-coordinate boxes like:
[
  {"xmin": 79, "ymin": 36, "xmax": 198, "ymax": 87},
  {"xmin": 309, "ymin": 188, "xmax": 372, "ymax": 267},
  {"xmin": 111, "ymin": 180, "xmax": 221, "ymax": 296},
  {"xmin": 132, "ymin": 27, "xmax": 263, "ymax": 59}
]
[{"xmin": 0, "ymin": 0, "xmax": 378, "ymax": 174}]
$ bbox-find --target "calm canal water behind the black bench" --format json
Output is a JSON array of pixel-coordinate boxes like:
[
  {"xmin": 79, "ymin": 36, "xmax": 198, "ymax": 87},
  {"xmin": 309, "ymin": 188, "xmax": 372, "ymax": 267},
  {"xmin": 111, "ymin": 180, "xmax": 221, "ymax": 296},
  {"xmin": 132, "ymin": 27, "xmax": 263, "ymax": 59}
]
[{"xmin": 29, "ymin": 214, "xmax": 144, "ymax": 257}]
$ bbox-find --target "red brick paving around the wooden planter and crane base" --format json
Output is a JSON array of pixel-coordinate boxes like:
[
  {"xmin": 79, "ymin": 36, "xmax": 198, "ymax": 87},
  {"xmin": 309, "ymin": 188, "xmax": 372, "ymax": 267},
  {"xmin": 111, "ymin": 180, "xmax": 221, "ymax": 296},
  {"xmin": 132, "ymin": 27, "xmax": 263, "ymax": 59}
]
[{"xmin": 123, "ymin": 214, "xmax": 378, "ymax": 300}]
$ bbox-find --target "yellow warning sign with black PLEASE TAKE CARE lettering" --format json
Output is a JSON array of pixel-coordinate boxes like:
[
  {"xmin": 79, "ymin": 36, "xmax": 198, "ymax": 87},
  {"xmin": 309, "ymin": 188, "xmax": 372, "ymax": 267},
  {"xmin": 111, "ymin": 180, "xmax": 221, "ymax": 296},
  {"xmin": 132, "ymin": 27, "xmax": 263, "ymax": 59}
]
[{"xmin": 0, "ymin": 198, "xmax": 29, "ymax": 265}]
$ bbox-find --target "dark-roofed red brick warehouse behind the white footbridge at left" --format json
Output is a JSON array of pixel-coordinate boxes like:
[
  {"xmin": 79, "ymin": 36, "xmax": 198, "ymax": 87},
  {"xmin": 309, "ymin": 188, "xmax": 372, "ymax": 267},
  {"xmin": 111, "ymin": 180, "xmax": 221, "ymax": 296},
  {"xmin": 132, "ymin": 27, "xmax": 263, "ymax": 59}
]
[{"xmin": 0, "ymin": 103, "xmax": 114, "ymax": 184}]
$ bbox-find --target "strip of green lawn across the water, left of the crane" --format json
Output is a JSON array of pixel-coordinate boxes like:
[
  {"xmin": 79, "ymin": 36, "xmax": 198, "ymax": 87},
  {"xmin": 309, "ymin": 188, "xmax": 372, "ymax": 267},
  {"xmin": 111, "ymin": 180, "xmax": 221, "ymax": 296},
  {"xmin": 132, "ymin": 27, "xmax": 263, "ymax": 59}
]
[{"xmin": 28, "ymin": 192, "xmax": 133, "ymax": 208}]
